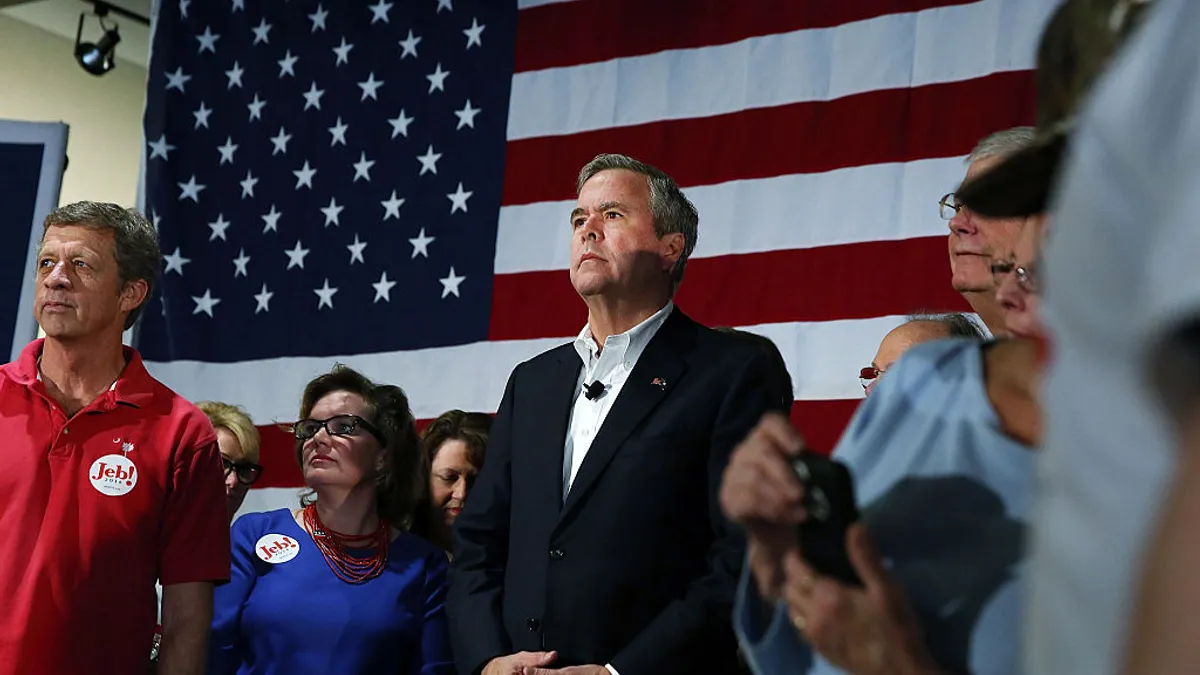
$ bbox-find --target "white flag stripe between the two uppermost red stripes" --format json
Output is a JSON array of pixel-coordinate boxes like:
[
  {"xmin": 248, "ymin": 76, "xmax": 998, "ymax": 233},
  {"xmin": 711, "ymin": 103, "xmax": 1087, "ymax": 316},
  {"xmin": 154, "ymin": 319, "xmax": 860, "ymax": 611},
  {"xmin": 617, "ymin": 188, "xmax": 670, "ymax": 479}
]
[{"xmin": 508, "ymin": 0, "xmax": 1055, "ymax": 141}]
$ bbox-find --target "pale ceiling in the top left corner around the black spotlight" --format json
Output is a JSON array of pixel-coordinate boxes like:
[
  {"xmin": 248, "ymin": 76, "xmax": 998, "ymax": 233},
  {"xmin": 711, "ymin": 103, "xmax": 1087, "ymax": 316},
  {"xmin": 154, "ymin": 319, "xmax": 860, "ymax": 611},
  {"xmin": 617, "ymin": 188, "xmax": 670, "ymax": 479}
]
[{"xmin": 0, "ymin": 0, "xmax": 152, "ymax": 67}]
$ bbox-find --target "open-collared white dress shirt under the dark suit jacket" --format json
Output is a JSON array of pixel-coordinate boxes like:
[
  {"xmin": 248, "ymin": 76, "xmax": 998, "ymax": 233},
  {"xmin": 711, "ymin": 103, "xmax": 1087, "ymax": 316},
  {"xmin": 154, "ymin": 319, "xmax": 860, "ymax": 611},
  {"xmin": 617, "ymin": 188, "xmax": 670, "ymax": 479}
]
[{"xmin": 563, "ymin": 301, "xmax": 674, "ymax": 502}]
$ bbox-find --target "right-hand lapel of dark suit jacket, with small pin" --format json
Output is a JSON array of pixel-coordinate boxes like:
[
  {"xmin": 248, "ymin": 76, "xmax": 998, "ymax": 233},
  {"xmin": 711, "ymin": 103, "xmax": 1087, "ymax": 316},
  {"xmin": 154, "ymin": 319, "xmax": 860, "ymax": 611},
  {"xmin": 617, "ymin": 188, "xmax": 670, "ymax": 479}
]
[{"xmin": 559, "ymin": 309, "xmax": 691, "ymax": 522}]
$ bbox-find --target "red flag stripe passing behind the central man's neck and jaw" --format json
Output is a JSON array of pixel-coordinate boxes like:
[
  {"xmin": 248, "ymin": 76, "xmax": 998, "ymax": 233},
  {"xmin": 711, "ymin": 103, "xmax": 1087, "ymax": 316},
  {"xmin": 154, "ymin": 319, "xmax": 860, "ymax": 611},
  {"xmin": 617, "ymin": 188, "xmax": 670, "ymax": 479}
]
[{"xmin": 488, "ymin": 237, "xmax": 970, "ymax": 340}]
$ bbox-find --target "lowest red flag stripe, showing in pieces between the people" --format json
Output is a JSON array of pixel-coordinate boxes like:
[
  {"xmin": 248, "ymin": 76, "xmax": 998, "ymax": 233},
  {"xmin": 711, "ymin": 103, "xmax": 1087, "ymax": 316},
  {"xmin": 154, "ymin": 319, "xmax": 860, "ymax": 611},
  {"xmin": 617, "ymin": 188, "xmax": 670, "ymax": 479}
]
[{"xmin": 254, "ymin": 400, "xmax": 859, "ymax": 489}]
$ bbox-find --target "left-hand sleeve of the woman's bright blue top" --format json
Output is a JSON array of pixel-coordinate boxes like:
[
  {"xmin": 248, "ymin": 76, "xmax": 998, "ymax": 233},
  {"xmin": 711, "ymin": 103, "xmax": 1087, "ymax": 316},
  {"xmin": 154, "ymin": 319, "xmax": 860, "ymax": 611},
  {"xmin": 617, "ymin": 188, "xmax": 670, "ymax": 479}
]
[{"xmin": 208, "ymin": 515, "xmax": 260, "ymax": 675}]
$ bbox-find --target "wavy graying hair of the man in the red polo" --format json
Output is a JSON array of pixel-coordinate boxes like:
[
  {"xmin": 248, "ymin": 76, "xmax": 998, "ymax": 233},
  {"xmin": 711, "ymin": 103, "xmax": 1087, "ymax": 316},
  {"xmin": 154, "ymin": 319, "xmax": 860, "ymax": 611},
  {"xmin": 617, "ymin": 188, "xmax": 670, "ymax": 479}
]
[{"xmin": 42, "ymin": 202, "xmax": 162, "ymax": 329}]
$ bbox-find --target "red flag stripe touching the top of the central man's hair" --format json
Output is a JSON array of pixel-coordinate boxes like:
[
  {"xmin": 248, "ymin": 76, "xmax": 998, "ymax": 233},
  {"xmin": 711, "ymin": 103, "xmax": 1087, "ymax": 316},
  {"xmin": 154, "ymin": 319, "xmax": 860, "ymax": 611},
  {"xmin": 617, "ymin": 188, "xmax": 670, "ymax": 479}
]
[{"xmin": 502, "ymin": 71, "xmax": 1034, "ymax": 205}]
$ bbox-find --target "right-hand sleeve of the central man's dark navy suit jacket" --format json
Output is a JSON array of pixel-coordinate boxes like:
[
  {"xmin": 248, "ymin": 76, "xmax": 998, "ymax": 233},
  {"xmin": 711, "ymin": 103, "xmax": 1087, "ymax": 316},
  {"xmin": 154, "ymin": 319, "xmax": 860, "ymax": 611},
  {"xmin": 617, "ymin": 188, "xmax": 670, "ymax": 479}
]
[{"xmin": 611, "ymin": 353, "xmax": 784, "ymax": 675}]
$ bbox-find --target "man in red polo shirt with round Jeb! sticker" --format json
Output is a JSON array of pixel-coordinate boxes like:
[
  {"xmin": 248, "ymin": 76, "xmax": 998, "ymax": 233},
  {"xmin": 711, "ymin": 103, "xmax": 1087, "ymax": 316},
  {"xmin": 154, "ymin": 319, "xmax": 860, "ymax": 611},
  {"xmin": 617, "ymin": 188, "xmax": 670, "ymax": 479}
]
[{"xmin": 0, "ymin": 202, "xmax": 229, "ymax": 675}]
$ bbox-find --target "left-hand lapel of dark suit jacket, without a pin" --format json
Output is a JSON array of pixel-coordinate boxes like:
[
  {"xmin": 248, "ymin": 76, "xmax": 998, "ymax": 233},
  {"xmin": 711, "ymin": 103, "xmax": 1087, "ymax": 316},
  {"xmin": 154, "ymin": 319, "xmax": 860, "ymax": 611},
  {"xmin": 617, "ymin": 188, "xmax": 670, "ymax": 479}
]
[{"xmin": 529, "ymin": 348, "xmax": 583, "ymax": 518}]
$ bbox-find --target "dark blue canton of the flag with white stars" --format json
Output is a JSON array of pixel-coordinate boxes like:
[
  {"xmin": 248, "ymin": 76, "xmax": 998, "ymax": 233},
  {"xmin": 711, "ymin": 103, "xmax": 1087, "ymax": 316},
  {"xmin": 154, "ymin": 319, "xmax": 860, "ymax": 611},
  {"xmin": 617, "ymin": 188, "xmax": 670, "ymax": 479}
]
[{"xmin": 138, "ymin": 0, "xmax": 516, "ymax": 363}]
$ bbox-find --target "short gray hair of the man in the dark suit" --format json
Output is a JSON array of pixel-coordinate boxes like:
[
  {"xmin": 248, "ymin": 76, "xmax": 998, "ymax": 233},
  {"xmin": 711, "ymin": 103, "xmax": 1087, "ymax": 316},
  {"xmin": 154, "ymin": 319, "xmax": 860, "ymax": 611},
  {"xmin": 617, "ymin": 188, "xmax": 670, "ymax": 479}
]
[{"xmin": 575, "ymin": 154, "xmax": 700, "ymax": 288}]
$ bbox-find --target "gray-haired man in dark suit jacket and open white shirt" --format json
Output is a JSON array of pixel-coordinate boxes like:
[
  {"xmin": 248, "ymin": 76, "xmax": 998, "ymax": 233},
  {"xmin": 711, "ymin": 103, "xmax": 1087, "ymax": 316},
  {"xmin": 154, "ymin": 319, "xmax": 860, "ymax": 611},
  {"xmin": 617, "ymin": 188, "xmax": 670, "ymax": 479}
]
[{"xmin": 446, "ymin": 155, "xmax": 791, "ymax": 675}]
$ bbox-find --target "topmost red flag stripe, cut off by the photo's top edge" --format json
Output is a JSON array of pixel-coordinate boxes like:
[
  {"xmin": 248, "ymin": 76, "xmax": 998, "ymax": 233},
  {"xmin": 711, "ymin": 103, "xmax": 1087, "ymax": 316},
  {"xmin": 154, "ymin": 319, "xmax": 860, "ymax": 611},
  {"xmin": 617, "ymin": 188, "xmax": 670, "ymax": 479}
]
[{"xmin": 516, "ymin": 0, "xmax": 976, "ymax": 72}]
